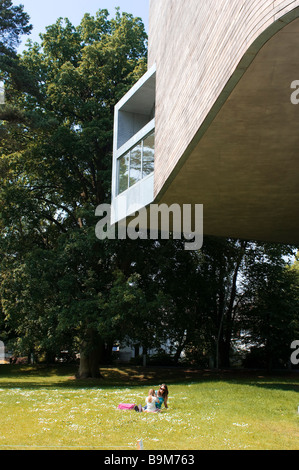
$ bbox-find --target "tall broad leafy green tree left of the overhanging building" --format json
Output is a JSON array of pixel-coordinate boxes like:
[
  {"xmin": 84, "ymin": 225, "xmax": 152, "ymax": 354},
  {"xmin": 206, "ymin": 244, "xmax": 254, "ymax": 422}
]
[{"xmin": 0, "ymin": 10, "xmax": 146, "ymax": 377}]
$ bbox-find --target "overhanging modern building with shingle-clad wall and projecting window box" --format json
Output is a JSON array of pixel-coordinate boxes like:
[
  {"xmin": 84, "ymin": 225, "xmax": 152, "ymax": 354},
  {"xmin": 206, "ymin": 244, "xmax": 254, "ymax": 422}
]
[{"xmin": 112, "ymin": 0, "xmax": 299, "ymax": 244}]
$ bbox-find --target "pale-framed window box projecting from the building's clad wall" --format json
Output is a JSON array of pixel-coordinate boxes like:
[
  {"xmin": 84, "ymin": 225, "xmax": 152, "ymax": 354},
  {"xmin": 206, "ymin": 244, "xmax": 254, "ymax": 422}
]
[{"xmin": 111, "ymin": 66, "xmax": 156, "ymax": 224}]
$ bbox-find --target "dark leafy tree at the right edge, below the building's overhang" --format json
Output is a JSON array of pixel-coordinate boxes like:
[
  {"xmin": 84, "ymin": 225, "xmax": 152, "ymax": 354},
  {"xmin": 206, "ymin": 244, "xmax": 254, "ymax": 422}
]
[{"xmin": 240, "ymin": 246, "xmax": 299, "ymax": 369}]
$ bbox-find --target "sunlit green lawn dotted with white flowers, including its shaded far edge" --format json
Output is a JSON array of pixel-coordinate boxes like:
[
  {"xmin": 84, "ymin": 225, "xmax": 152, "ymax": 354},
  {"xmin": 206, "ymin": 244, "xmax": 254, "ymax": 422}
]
[{"xmin": 0, "ymin": 365, "xmax": 299, "ymax": 450}]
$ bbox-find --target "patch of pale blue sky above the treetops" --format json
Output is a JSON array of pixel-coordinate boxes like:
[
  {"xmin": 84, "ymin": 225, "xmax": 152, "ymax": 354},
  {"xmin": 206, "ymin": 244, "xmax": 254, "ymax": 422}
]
[{"xmin": 12, "ymin": 0, "xmax": 149, "ymax": 52}]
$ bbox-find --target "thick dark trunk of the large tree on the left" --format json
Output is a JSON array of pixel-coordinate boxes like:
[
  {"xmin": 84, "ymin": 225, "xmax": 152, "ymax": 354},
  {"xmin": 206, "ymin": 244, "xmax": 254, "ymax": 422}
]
[{"xmin": 77, "ymin": 329, "xmax": 103, "ymax": 379}]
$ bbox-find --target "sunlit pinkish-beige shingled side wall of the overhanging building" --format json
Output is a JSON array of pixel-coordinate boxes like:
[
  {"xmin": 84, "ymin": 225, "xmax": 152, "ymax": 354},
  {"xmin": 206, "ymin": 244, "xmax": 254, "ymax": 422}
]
[{"xmin": 149, "ymin": 0, "xmax": 299, "ymax": 195}]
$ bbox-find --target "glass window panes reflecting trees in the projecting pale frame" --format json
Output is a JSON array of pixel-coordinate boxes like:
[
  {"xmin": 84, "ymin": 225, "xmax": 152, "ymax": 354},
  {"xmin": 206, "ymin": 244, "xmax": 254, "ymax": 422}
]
[{"xmin": 118, "ymin": 132, "xmax": 155, "ymax": 194}]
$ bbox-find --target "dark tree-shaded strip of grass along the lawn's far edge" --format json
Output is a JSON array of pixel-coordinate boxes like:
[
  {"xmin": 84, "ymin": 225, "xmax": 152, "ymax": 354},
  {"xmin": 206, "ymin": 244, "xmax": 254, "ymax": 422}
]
[{"xmin": 0, "ymin": 364, "xmax": 299, "ymax": 392}]
